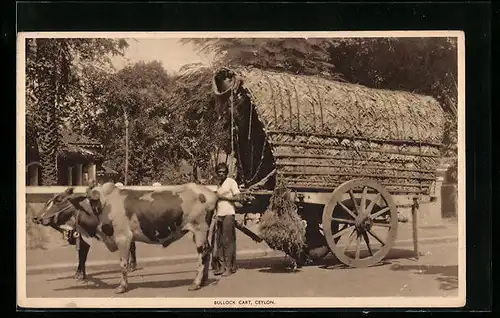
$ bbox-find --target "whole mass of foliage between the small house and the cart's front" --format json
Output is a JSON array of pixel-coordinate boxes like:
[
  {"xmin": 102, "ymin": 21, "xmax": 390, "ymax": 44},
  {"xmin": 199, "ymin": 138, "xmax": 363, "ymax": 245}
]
[{"xmin": 74, "ymin": 61, "xmax": 228, "ymax": 184}]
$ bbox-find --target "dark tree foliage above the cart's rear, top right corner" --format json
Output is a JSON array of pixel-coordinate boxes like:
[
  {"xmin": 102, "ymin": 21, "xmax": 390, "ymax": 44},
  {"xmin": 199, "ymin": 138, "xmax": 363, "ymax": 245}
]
[{"xmin": 328, "ymin": 37, "xmax": 458, "ymax": 115}]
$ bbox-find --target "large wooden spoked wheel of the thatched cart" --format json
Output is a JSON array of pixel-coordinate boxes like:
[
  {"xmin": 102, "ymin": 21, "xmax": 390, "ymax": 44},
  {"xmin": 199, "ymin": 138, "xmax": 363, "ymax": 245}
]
[{"xmin": 323, "ymin": 179, "xmax": 398, "ymax": 267}]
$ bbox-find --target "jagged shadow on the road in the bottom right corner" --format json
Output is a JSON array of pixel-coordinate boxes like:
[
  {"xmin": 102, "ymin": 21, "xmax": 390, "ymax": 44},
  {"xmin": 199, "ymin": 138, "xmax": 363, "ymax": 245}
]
[{"xmin": 390, "ymin": 264, "xmax": 458, "ymax": 290}]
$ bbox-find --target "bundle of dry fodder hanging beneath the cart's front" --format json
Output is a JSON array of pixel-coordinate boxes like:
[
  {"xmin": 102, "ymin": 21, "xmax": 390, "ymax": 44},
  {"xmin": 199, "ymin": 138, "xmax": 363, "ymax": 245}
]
[{"xmin": 259, "ymin": 180, "xmax": 306, "ymax": 268}]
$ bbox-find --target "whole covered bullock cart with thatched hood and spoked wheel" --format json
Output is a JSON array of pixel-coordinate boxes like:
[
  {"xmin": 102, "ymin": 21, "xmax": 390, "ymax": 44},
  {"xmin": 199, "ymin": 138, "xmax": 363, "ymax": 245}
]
[{"xmin": 212, "ymin": 68, "xmax": 445, "ymax": 267}]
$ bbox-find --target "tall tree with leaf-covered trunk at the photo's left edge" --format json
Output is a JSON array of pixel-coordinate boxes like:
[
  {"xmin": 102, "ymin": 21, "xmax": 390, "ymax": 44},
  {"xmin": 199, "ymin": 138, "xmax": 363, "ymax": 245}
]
[{"xmin": 26, "ymin": 38, "xmax": 127, "ymax": 185}]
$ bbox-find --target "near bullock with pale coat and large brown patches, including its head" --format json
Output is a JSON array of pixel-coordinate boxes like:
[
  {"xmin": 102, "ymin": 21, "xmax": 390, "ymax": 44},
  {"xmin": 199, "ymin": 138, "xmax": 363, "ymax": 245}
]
[{"xmin": 36, "ymin": 183, "xmax": 232, "ymax": 293}]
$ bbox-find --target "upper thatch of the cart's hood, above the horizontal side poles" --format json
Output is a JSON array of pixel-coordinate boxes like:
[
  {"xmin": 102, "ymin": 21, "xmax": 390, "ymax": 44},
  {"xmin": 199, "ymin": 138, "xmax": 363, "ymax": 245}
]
[{"xmin": 232, "ymin": 68, "xmax": 445, "ymax": 143}]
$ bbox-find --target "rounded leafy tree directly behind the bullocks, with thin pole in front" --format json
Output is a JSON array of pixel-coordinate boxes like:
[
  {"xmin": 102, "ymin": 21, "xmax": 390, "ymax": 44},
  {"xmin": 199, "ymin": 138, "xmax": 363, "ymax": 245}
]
[{"xmin": 75, "ymin": 61, "xmax": 171, "ymax": 184}]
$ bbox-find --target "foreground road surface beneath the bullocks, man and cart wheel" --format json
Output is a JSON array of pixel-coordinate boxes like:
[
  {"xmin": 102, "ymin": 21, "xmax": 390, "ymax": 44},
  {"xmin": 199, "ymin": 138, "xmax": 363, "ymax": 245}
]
[{"xmin": 26, "ymin": 242, "xmax": 458, "ymax": 300}]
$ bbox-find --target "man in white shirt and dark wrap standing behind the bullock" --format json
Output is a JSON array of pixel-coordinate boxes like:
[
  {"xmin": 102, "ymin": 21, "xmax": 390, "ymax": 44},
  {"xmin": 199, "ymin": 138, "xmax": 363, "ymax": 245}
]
[{"xmin": 212, "ymin": 163, "xmax": 243, "ymax": 276}]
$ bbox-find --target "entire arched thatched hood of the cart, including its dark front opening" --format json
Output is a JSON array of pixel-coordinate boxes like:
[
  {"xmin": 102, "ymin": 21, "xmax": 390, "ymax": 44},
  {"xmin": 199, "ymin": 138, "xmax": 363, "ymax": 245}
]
[{"xmin": 213, "ymin": 68, "xmax": 444, "ymax": 193}]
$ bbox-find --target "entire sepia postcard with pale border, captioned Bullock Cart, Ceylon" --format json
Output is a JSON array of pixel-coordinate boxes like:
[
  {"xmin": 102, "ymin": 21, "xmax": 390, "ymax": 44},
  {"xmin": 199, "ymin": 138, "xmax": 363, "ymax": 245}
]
[{"xmin": 17, "ymin": 31, "xmax": 466, "ymax": 308}]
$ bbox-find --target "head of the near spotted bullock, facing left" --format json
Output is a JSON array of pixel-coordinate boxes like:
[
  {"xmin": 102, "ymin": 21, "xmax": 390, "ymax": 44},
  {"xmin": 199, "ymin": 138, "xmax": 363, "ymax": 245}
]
[{"xmin": 32, "ymin": 187, "xmax": 91, "ymax": 232}]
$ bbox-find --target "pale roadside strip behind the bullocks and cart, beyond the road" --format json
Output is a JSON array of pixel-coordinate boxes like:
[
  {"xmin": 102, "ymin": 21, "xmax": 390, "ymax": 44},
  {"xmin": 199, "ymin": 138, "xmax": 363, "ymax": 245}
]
[{"xmin": 26, "ymin": 220, "xmax": 458, "ymax": 274}]
